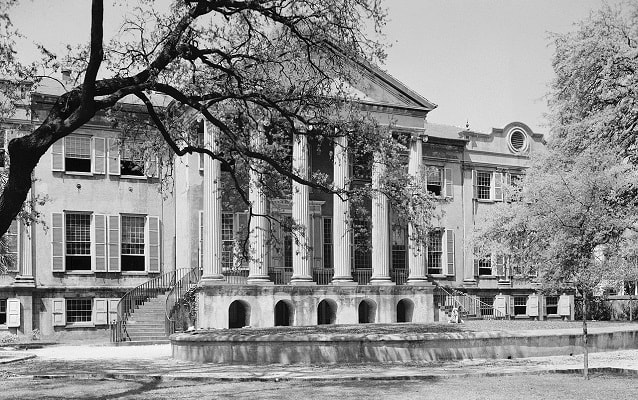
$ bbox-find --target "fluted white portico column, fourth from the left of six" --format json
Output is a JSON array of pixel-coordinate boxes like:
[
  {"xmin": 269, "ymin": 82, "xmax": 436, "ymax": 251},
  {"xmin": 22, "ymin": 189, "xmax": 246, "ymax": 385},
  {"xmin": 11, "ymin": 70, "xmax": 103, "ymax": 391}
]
[{"xmin": 332, "ymin": 136, "xmax": 354, "ymax": 285}]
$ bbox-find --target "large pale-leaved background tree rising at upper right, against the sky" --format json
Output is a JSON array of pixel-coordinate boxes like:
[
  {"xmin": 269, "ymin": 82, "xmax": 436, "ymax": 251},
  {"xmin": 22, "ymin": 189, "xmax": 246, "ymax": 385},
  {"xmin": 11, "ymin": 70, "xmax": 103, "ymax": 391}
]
[{"xmin": 549, "ymin": 2, "xmax": 638, "ymax": 158}]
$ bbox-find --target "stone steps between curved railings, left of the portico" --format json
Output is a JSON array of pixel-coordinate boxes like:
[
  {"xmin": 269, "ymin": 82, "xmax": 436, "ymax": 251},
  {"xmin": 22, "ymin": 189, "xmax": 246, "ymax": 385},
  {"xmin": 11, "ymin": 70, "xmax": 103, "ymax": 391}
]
[{"xmin": 126, "ymin": 294, "xmax": 168, "ymax": 342}]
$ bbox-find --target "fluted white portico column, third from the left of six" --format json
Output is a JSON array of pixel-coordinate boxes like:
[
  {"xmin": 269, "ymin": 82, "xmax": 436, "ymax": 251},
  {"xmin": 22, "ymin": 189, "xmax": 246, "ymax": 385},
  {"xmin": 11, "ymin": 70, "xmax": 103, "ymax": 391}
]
[{"xmin": 290, "ymin": 134, "xmax": 314, "ymax": 285}]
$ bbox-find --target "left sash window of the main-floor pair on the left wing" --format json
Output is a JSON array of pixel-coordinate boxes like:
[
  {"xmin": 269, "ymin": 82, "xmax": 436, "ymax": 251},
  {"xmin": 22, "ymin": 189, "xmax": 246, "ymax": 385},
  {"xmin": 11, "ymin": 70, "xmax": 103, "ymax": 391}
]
[{"xmin": 64, "ymin": 213, "xmax": 91, "ymax": 271}]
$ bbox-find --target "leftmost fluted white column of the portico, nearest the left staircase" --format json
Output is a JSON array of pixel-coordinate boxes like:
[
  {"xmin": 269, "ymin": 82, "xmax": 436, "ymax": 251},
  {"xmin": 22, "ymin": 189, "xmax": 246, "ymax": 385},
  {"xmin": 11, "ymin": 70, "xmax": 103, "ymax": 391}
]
[{"xmin": 202, "ymin": 122, "xmax": 224, "ymax": 282}]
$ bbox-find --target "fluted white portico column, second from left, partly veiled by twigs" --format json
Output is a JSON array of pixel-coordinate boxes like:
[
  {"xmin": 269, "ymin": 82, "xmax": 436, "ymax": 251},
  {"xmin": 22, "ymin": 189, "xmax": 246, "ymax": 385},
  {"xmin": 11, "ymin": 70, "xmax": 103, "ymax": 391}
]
[{"xmin": 248, "ymin": 127, "xmax": 271, "ymax": 284}]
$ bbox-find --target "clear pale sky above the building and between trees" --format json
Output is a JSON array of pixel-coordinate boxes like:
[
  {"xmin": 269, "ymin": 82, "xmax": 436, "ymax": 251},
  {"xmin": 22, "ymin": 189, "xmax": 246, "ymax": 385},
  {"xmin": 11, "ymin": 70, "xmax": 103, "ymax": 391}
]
[{"xmin": 6, "ymin": 0, "xmax": 614, "ymax": 133}]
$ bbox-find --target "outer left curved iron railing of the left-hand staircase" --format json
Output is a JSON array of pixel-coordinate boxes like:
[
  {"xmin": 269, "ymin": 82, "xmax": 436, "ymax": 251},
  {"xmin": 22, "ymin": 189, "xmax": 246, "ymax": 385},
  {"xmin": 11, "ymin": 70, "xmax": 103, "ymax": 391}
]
[{"xmin": 111, "ymin": 268, "xmax": 194, "ymax": 342}]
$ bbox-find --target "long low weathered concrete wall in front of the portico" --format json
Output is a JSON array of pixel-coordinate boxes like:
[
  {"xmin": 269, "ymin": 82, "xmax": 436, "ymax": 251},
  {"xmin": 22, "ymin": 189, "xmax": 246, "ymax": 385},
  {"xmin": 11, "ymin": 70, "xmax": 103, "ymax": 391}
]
[{"xmin": 171, "ymin": 327, "xmax": 638, "ymax": 364}]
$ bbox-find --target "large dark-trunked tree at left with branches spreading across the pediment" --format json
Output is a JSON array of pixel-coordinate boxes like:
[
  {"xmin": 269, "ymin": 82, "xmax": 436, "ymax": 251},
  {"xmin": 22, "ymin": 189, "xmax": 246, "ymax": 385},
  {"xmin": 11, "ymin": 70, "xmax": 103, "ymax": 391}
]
[{"xmin": 0, "ymin": 0, "xmax": 432, "ymax": 242}]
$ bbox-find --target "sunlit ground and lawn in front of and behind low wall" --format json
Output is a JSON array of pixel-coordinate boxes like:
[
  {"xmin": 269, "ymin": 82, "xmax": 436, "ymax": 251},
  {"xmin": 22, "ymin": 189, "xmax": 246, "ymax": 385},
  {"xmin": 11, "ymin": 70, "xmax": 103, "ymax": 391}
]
[{"xmin": 0, "ymin": 321, "xmax": 638, "ymax": 399}]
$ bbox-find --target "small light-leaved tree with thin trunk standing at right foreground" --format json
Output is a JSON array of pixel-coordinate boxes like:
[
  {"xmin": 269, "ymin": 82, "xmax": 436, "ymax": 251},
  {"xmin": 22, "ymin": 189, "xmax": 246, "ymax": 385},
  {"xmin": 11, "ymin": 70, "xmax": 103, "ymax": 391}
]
[{"xmin": 475, "ymin": 147, "xmax": 638, "ymax": 378}]
